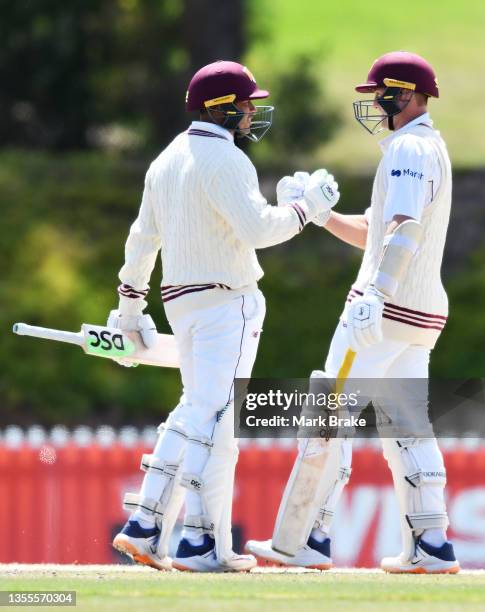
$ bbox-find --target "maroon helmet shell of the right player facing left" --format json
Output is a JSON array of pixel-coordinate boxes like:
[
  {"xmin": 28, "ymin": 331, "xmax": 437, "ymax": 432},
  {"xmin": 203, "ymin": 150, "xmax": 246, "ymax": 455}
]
[{"xmin": 355, "ymin": 51, "xmax": 440, "ymax": 98}]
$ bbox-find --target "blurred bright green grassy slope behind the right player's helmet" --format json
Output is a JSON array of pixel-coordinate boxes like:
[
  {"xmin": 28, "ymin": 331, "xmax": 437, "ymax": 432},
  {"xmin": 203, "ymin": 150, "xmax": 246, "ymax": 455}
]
[{"xmin": 247, "ymin": 0, "xmax": 485, "ymax": 170}]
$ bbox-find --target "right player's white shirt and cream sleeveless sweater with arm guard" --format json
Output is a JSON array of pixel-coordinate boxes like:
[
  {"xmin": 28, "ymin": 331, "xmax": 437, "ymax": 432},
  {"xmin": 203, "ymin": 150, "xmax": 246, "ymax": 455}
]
[{"xmin": 343, "ymin": 113, "xmax": 452, "ymax": 348}]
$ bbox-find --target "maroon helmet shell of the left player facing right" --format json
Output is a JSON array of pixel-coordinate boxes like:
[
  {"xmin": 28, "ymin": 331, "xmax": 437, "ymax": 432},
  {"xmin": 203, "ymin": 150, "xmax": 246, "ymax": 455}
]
[{"xmin": 185, "ymin": 60, "xmax": 269, "ymax": 111}]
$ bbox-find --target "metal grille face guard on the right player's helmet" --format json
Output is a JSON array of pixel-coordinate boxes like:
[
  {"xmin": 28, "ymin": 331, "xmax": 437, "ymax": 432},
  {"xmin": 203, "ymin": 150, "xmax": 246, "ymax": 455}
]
[{"xmin": 353, "ymin": 87, "xmax": 411, "ymax": 134}]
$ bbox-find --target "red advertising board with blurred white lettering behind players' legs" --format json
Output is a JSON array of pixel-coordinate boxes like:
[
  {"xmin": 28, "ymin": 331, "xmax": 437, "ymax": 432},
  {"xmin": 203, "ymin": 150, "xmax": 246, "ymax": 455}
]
[{"xmin": 0, "ymin": 441, "xmax": 485, "ymax": 567}]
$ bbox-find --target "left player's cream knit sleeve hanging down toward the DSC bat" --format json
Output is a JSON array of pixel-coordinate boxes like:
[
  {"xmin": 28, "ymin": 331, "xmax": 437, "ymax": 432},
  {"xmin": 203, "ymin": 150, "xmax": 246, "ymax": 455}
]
[{"xmin": 118, "ymin": 170, "xmax": 161, "ymax": 315}]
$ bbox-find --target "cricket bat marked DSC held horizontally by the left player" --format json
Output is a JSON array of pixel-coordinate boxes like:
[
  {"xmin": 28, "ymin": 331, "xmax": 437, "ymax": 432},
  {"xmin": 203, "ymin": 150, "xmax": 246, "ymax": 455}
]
[{"xmin": 13, "ymin": 323, "xmax": 180, "ymax": 368}]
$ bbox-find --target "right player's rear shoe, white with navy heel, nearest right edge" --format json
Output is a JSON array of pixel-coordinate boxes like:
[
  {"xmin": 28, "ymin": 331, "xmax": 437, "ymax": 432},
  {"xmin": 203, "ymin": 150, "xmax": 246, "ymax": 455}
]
[{"xmin": 381, "ymin": 539, "xmax": 460, "ymax": 574}]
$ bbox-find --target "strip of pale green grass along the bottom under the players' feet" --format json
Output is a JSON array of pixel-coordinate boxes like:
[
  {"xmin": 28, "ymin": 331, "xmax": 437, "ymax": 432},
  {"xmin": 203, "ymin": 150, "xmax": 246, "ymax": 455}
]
[{"xmin": 0, "ymin": 565, "xmax": 485, "ymax": 612}]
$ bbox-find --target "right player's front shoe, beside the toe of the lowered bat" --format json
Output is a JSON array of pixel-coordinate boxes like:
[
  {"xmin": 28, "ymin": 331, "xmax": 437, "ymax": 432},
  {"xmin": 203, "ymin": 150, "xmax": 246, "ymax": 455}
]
[{"xmin": 246, "ymin": 536, "xmax": 332, "ymax": 570}]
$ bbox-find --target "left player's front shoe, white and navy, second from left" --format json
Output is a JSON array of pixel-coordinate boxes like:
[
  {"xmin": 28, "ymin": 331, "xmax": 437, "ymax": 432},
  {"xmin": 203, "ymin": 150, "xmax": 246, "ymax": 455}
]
[{"xmin": 172, "ymin": 534, "xmax": 257, "ymax": 572}]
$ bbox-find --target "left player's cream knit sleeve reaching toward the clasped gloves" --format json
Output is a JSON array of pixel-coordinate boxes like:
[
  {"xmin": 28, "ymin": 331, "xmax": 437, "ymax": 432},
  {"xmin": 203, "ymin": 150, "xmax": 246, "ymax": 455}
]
[{"xmin": 208, "ymin": 151, "xmax": 308, "ymax": 249}]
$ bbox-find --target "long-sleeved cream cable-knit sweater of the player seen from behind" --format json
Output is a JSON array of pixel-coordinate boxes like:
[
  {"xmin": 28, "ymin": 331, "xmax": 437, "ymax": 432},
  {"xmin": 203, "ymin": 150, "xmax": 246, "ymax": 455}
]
[{"xmin": 119, "ymin": 121, "xmax": 317, "ymax": 314}]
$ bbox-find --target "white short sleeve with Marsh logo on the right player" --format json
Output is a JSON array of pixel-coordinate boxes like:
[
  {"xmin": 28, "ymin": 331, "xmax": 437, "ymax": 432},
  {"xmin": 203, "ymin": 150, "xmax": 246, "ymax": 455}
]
[{"xmin": 384, "ymin": 135, "xmax": 437, "ymax": 223}]
